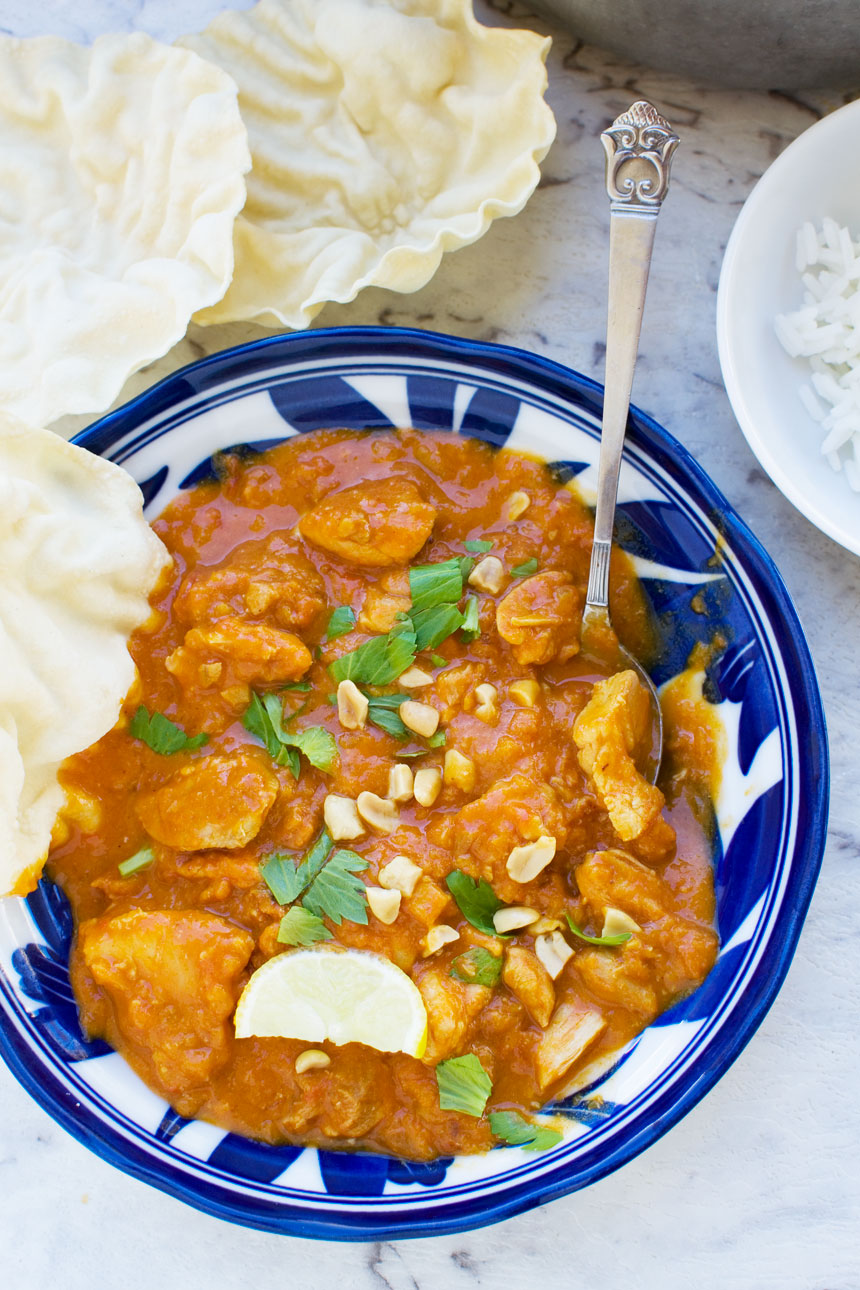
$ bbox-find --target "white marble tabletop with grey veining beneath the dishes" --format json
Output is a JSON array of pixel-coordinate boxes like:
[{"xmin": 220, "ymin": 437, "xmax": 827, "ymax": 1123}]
[{"xmin": 0, "ymin": 0, "xmax": 860, "ymax": 1290}]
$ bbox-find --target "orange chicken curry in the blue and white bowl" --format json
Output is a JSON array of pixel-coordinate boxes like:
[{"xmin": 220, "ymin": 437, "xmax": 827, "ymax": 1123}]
[{"xmin": 49, "ymin": 430, "xmax": 717, "ymax": 1158}]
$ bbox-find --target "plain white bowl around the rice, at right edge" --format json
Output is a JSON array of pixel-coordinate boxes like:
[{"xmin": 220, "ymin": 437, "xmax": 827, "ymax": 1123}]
[{"xmin": 717, "ymin": 92, "xmax": 860, "ymax": 555}]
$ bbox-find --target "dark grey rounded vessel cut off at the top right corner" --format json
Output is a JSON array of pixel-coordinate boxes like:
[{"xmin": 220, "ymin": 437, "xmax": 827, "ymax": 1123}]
[{"xmin": 535, "ymin": 0, "xmax": 860, "ymax": 90}]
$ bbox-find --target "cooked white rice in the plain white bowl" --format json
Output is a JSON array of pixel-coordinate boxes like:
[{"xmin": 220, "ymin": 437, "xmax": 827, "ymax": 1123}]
[{"xmin": 775, "ymin": 219, "xmax": 860, "ymax": 493}]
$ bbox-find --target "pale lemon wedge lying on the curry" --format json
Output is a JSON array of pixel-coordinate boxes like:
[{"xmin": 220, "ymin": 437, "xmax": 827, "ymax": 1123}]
[{"xmin": 233, "ymin": 948, "xmax": 427, "ymax": 1057}]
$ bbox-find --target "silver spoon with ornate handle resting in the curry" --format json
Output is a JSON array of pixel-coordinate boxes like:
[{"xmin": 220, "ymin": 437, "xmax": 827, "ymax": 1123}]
[{"xmin": 583, "ymin": 102, "xmax": 678, "ymax": 783}]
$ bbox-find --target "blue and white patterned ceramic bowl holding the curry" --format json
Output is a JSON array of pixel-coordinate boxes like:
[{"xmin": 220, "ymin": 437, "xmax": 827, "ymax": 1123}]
[{"xmin": 0, "ymin": 329, "xmax": 828, "ymax": 1240}]
